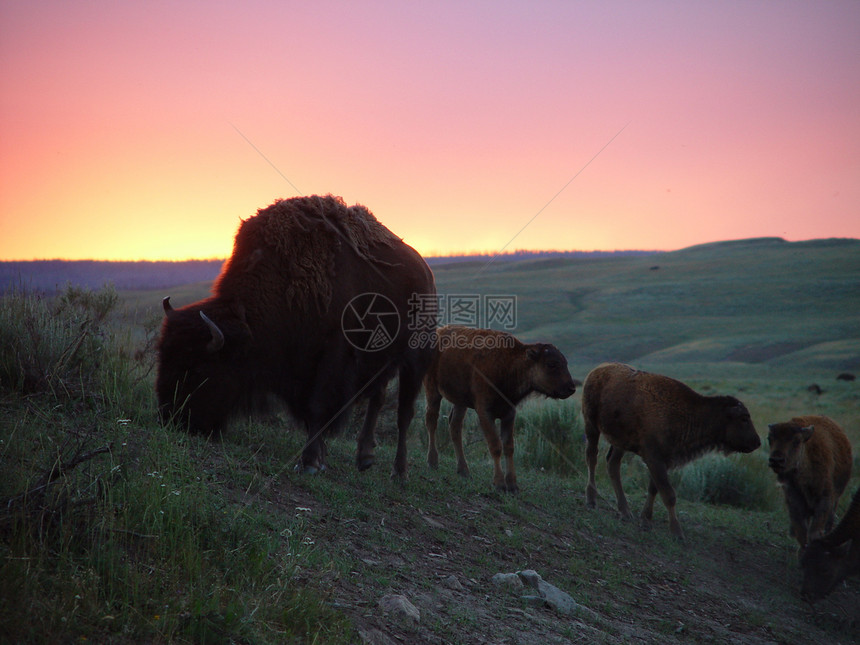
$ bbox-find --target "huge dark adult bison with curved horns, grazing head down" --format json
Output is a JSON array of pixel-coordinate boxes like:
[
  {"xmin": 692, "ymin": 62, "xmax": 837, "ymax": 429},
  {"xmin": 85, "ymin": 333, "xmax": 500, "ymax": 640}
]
[{"xmin": 156, "ymin": 195, "xmax": 436, "ymax": 476}]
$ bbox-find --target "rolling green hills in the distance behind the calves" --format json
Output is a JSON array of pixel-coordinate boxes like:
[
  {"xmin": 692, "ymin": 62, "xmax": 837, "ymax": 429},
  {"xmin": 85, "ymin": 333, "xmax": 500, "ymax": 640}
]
[{"xmin": 435, "ymin": 239, "xmax": 860, "ymax": 376}]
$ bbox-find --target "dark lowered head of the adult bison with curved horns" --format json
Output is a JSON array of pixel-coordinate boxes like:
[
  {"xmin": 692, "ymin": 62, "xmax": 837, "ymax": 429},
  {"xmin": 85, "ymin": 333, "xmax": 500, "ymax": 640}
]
[{"xmin": 155, "ymin": 298, "xmax": 251, "ymax": 434}]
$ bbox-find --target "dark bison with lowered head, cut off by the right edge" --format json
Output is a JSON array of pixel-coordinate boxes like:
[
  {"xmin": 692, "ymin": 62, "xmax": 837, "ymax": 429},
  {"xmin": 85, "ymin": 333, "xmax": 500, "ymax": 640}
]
[{"xmin": 800, "ymin": 489, "xmax": 860, "ymax": 602}]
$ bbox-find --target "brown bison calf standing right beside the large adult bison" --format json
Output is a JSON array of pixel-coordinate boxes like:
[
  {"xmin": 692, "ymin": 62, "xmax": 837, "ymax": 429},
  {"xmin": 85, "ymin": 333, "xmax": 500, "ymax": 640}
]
[{"xmin": 424, "ymin": 325, "xmax": 576, "ymax": 492}]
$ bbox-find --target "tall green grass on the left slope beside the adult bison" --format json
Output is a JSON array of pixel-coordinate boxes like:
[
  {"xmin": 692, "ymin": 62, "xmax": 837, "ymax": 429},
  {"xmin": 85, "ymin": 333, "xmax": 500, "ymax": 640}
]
[{"xmin": 0, "ymin": 288, "xmax": 349, "ymax": 643}]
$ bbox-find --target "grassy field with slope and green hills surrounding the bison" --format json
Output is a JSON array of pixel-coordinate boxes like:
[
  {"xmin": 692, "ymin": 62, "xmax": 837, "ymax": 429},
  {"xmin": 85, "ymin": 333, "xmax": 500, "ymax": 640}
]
[{"xmin": 0, "ymin": 239, "xmax": 860, "ymax": 644}]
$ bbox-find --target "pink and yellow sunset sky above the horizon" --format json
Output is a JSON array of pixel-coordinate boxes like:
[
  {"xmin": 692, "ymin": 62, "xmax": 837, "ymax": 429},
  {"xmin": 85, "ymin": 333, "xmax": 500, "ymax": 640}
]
[{"xmin": 0, "ymin": 0, "xmax": 860, "ymax": 260}]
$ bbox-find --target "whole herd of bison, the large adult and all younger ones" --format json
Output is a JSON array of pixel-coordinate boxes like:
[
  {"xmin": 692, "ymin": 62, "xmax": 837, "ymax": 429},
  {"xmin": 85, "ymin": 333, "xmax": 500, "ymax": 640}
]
[{"xmin": 156, "ymin": 195, "xmax": 860, "ymax": 601}]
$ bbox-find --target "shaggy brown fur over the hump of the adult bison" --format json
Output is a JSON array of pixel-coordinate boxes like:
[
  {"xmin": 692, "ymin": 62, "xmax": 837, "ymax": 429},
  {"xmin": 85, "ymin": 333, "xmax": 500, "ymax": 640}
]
[{"xmin": 214, "ymin": 195, "xmax": 402, "ymax": 312}]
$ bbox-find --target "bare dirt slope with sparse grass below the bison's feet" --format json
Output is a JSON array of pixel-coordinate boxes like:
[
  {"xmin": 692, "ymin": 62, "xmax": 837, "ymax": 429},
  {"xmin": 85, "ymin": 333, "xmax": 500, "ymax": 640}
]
[{"xmin": 227, "ymin": 430, "xmax": 860, "ymax": 645}]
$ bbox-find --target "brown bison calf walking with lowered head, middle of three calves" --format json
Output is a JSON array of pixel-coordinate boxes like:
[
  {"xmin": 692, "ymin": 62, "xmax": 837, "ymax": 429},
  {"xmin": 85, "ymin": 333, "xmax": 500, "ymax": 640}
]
[{"xmin": 582, "ymin": 363, "xmax": 761, "ymax": 538}]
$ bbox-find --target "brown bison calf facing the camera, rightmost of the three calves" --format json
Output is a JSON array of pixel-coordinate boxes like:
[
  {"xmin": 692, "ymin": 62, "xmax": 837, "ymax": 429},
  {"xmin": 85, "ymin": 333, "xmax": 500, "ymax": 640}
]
[{"xmin": 767, "ymin": 416, "xmax": 852, "ymax": 547}]
